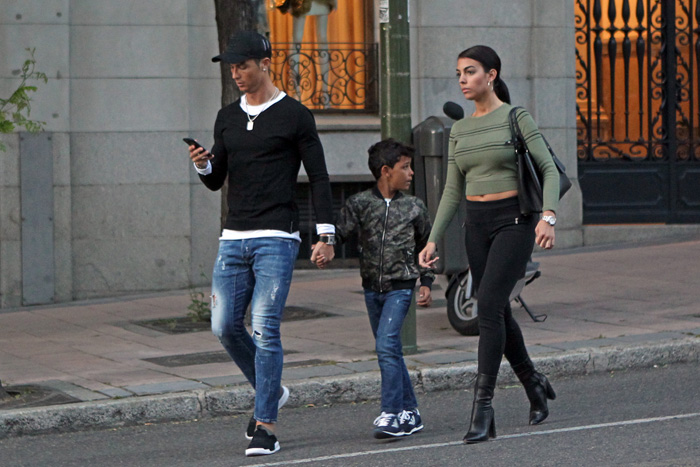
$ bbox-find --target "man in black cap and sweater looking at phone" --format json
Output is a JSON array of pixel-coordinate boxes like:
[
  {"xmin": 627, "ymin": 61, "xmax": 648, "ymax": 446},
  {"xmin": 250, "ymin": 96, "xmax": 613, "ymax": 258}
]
[{"xmin": 190, "ymin": 31, "xmax": 335, "ymax": 456}]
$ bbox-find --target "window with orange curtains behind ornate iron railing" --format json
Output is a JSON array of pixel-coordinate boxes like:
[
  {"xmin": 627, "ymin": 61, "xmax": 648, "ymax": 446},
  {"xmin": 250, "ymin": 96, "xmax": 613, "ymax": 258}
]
[{"xmin": 268, "ymin": 0, "xmax": 378, "ymax": 113}]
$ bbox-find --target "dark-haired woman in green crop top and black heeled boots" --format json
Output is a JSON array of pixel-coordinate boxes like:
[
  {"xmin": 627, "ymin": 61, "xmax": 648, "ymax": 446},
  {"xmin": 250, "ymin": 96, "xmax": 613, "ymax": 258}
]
[{"xmin": 419, "ymin": 45, "xmax": 559, "ymax": 443}]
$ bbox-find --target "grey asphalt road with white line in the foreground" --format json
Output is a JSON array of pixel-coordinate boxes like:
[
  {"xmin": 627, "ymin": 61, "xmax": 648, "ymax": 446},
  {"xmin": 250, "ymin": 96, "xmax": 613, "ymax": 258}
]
[{"xmin": 0, "ymin": 364, "xmax": 700, "ymax": 467}]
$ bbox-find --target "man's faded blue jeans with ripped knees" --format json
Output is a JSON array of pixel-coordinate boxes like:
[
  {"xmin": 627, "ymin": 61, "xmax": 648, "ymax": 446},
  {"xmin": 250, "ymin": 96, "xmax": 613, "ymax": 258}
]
[{"xmin": 211, "ymin": 238, "xmax": 299, "ymax": 423}]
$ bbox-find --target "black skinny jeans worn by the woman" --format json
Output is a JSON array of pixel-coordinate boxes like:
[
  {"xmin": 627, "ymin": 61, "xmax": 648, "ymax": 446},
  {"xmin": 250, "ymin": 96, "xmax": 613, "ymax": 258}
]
[{"xmin": 465, "ymin": 197, "xmax": 538, "ymax": 376}]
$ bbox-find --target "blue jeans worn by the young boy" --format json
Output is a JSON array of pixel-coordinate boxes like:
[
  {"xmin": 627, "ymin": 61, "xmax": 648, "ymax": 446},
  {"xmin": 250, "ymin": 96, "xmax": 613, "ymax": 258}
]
[{"xmin": 365, "ymin": 289, "xmax": 418, "ymax": 414}]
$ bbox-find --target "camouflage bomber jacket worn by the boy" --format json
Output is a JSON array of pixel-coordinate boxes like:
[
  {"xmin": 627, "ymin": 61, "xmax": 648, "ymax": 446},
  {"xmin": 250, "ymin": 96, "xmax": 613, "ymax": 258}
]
[{"xmin": 335, "ymin": 186, "xmax": 435, "ymax": 293}]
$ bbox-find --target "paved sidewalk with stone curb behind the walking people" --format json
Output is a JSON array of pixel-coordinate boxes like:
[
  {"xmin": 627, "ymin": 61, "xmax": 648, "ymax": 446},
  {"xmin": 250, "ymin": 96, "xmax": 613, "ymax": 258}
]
[{"xmin": 0, "ymin": 241, "xmax": 700, "ymax": 437}]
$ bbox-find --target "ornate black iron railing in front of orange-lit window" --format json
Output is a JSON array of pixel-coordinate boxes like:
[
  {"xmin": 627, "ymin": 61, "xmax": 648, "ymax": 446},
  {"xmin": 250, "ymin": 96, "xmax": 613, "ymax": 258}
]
[{"xmin": 271, "ymin": 43, "xmax": 379, "ymax": 113}]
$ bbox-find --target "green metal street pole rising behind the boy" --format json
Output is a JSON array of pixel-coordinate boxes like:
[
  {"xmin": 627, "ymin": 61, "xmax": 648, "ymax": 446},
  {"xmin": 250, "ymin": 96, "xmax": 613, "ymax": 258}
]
[{"xmin": 379, "ymin": 0, "xmax": 418, "ymax": 355}]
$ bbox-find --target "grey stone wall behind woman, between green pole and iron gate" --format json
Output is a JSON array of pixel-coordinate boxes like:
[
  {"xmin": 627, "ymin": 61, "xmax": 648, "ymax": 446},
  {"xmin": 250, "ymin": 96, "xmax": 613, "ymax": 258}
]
[{"xmin": 410, "ymin": 0, "xmax": 582, "ymax": 247}]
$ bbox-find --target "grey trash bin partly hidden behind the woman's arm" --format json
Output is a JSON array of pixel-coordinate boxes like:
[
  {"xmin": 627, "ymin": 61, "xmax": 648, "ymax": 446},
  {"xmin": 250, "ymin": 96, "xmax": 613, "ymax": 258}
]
[{"xmin": 413, "ymin": 117, "xmax": 469, "ymax": 276}]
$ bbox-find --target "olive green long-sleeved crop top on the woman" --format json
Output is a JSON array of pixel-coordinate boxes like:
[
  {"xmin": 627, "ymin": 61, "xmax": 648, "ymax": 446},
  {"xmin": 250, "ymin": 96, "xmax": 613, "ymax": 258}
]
[{"xmin": 429, "ymin": 104, "xmax": 559, "ymax": 242}]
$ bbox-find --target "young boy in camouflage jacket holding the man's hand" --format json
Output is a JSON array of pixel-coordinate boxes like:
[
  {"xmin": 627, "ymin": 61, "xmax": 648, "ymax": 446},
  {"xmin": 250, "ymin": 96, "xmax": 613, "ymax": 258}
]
[{"xmin": 316, "ymin": 139, "xmax": 435, "ymax": 439}]
